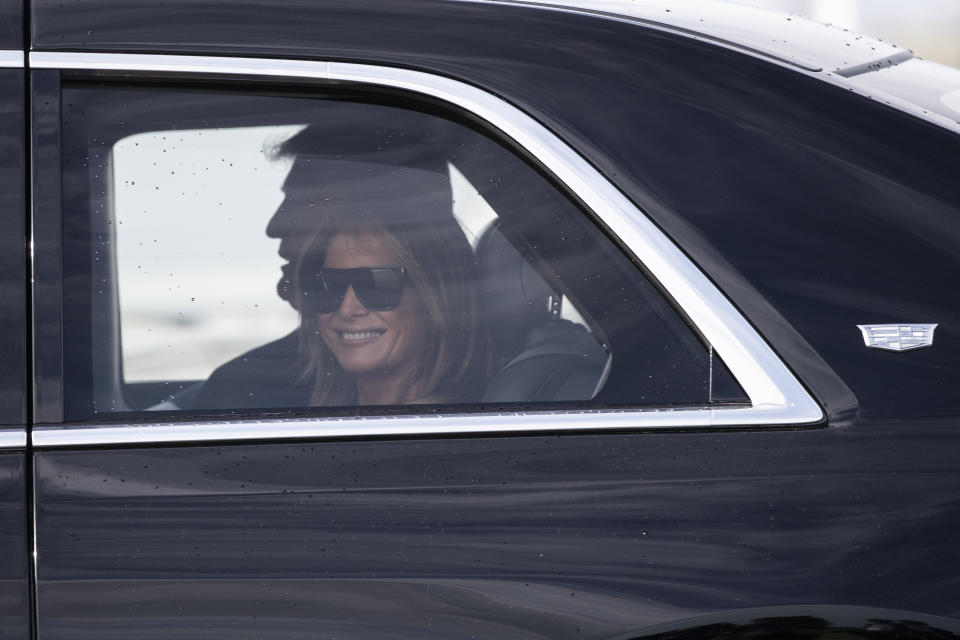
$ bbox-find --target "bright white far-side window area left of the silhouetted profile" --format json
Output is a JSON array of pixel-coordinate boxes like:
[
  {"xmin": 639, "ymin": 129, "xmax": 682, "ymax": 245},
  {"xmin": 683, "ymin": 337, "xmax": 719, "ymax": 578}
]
[{"xmin": 111, "ymin": 126, "xmax": 302, "ymax": 382}]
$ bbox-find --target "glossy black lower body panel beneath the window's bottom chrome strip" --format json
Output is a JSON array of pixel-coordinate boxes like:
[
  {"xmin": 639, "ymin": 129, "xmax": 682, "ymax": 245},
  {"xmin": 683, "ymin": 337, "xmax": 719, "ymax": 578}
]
[{"xmin": 37, "ymin": 424, "xmax": 960, "ymax": 638}]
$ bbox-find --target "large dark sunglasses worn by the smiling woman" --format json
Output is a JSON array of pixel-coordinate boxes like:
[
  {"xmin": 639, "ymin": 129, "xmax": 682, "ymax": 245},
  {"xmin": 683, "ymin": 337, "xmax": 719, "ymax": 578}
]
[{"xmin": 300, "ymin": 266, "xmax": 407, "ymax": 313}]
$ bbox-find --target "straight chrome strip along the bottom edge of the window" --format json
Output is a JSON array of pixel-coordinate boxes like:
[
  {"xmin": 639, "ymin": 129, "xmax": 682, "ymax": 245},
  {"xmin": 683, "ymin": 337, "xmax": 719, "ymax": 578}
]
[{"xmin": 33, "ymin": 407, "xmax": 808, "ymax": 448}]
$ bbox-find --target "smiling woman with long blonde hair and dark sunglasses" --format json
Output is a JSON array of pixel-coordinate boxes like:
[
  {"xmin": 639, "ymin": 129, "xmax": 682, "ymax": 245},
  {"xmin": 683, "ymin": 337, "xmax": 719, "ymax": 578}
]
[{"xmin": 300, "ymin": 225, "xmax": 490, "ymax": 405}]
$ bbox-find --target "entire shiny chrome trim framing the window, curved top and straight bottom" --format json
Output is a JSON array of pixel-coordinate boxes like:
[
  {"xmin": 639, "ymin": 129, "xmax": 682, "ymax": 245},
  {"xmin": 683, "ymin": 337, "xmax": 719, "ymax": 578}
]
[{"xmin": 30, "ymin": 52, "xmax": 823, "ymax": 446}]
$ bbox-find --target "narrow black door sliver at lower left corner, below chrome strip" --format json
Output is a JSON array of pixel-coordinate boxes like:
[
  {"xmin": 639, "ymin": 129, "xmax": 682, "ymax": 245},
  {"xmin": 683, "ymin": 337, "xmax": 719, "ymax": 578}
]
[{"xmin": 0, "ymin": 452, "xmax": 30, "ymax": 640}]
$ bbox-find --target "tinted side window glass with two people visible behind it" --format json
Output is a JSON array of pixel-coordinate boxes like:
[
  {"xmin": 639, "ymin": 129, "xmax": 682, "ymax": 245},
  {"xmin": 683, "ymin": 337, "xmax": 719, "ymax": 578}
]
[{"xmin": 63, "ymin": 86, "xmax": 745, "ymax": 420}]
